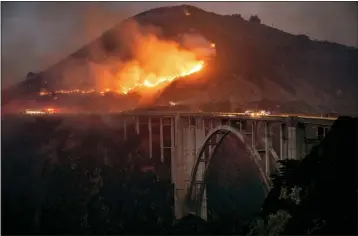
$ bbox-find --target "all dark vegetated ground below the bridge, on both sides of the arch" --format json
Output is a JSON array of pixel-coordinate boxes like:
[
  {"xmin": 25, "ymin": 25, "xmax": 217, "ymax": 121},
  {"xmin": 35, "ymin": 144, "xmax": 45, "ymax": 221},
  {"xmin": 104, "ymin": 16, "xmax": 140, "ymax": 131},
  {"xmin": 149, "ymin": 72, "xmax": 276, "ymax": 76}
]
[{"xmin": 2, "ymin": 117, "xmax": 358, "ymax": 235}]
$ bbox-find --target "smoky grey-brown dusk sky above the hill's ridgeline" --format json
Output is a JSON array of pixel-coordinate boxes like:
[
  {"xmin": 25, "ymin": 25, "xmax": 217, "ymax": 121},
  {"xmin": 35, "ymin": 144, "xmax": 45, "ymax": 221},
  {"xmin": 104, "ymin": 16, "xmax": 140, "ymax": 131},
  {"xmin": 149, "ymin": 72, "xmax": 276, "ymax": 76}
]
[{"xmin": 1, "ymin": 2, "xmax": 358, "ymax": 86}]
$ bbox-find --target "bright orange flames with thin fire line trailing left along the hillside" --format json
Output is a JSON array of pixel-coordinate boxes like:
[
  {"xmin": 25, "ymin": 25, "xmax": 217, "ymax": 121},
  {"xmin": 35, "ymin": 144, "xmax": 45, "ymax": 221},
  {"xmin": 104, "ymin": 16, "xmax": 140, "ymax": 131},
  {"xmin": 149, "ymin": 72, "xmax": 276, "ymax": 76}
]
[{"xmin": 40, "ymin": 19, "xmax": 205, "ymax": 95}]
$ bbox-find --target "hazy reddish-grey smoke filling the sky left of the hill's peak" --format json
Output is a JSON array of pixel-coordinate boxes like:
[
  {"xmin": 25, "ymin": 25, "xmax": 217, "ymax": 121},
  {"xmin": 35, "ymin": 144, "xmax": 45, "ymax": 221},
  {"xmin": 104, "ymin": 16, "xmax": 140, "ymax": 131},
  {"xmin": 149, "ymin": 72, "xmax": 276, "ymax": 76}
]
[{"xmin": 1, "ymin": 2, "xmax": 131, "ymax": 87}]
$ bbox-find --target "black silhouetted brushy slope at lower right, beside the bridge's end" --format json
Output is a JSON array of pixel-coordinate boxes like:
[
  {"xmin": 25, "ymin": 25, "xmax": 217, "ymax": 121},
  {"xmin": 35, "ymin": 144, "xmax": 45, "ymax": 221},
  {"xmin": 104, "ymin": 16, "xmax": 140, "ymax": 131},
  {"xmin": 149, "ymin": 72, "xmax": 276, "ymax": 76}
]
[{"xmin": 252, "ymin": 117, "xmax": 358, "ymax": 235}]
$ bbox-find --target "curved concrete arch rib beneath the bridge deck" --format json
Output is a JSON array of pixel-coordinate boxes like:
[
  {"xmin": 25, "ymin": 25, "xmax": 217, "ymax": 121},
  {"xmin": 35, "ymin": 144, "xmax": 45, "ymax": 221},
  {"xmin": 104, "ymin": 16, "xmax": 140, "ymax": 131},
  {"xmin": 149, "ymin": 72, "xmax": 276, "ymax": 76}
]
[{"xmin": 185, "ymin": 125, "xmax": 270, "ymax": 218}]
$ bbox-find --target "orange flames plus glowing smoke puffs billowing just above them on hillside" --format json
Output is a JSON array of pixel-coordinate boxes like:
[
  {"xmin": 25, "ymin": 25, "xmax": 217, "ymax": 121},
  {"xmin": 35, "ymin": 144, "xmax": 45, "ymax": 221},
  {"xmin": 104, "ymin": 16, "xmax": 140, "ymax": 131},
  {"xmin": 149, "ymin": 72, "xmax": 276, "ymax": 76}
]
[{"xmin": 40, "ymin": 18, "xmax": 213, "ymax": 99}]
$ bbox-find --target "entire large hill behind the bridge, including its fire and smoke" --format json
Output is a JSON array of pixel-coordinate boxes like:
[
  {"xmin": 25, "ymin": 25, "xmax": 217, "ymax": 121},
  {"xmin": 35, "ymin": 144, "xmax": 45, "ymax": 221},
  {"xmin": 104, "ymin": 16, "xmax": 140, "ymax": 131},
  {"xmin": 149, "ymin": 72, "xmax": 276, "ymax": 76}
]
[{"xmin": 3, "ymin": 6, "xmax": 358, "ymax": 114}]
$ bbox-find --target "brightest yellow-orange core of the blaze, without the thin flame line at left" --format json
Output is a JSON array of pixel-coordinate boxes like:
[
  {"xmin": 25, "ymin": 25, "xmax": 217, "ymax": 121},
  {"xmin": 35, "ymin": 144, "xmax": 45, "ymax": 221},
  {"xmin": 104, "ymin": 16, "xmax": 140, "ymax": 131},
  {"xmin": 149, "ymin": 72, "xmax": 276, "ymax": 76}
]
[{"xmin": 96, "ymin": 30, "xmax": 204, "ymax": 94}]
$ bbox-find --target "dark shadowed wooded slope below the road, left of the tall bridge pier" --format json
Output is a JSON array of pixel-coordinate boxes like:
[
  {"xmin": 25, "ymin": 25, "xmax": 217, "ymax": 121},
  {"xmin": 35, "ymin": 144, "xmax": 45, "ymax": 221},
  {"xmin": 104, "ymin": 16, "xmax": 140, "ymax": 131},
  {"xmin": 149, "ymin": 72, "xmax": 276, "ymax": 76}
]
[{"xmin": 2, "ymin": 116, "xmax": 260, "ymax": 234}]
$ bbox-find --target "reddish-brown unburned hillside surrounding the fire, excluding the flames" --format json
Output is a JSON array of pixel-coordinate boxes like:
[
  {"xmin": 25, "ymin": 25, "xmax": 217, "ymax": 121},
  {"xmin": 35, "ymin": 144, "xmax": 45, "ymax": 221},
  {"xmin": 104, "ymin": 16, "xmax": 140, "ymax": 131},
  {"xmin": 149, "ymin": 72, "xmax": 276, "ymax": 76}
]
[{"xmin": 3, "ymin": 5, "xmax": 358, "ymax": 114}]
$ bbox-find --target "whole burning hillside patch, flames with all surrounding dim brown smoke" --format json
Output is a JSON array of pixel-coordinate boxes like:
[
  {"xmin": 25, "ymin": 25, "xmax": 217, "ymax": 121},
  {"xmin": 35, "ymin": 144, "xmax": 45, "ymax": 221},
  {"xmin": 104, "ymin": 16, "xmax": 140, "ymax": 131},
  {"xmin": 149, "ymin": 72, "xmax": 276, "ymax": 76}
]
[{"xmin": 1, "ymin": 20, "xmax": 216, "ymax": 111}]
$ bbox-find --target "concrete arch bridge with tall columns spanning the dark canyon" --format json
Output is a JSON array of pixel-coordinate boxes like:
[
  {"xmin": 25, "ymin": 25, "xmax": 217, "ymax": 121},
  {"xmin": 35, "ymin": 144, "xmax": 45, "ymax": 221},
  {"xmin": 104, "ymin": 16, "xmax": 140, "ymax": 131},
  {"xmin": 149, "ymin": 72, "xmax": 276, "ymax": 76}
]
[{"xmin": 115, "ymin": 111, "xmax": 335, "ymax": 219}]
